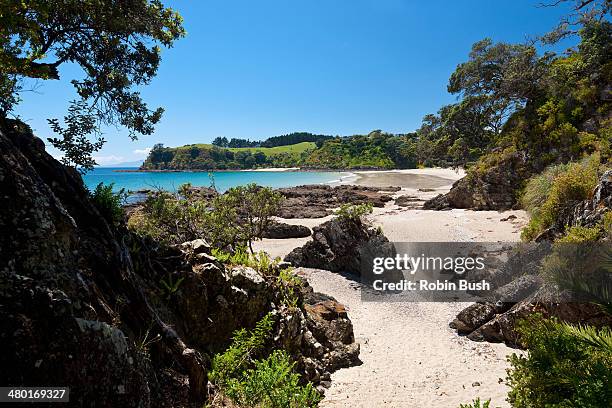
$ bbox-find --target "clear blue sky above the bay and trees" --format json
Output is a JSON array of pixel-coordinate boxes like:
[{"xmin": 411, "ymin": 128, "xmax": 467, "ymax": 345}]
[{"xmin": 16, "ymin": 0, "xmax": 566, "ymax": 164}]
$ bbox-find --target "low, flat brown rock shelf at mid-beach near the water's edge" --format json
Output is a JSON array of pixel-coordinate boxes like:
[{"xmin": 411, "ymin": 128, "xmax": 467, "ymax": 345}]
[{"xmin": 278, "ymin": 184, "xmax": 400, "ymax": 218}]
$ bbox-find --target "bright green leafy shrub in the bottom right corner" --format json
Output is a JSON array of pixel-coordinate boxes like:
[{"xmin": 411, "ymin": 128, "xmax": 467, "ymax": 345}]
[{"xmin": 508, "ymin": 317, "xmax": 612, "ymax": 408}]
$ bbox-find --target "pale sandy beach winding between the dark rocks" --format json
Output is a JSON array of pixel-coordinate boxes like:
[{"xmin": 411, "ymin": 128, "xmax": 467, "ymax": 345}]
[{"xmin": 256, "ymin": 169, "xmax": 527, "ymax": 408}]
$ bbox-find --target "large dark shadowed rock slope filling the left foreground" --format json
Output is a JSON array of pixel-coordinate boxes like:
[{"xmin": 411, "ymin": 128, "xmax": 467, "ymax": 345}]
[{"xmin": 0, "ymin": 120, "xmax": 207, "ymax": 407}]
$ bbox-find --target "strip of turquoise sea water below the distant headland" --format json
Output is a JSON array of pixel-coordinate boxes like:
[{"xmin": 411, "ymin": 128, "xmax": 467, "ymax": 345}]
[{"xmin": 83, "ymin": 167, "xmax": 350, "ymax": 191}]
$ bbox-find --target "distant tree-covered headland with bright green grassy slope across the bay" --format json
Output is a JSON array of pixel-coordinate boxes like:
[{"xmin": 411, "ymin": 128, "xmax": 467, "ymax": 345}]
[{"xmin": 141, "ymin": 130, "xmax": 431, "ymax": 170}]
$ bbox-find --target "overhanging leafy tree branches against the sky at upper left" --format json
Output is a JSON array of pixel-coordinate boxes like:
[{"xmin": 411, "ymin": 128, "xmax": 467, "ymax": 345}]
[{"xmin": 0, "ymin": 0, "xmax": 185, "ymax": 168}]
